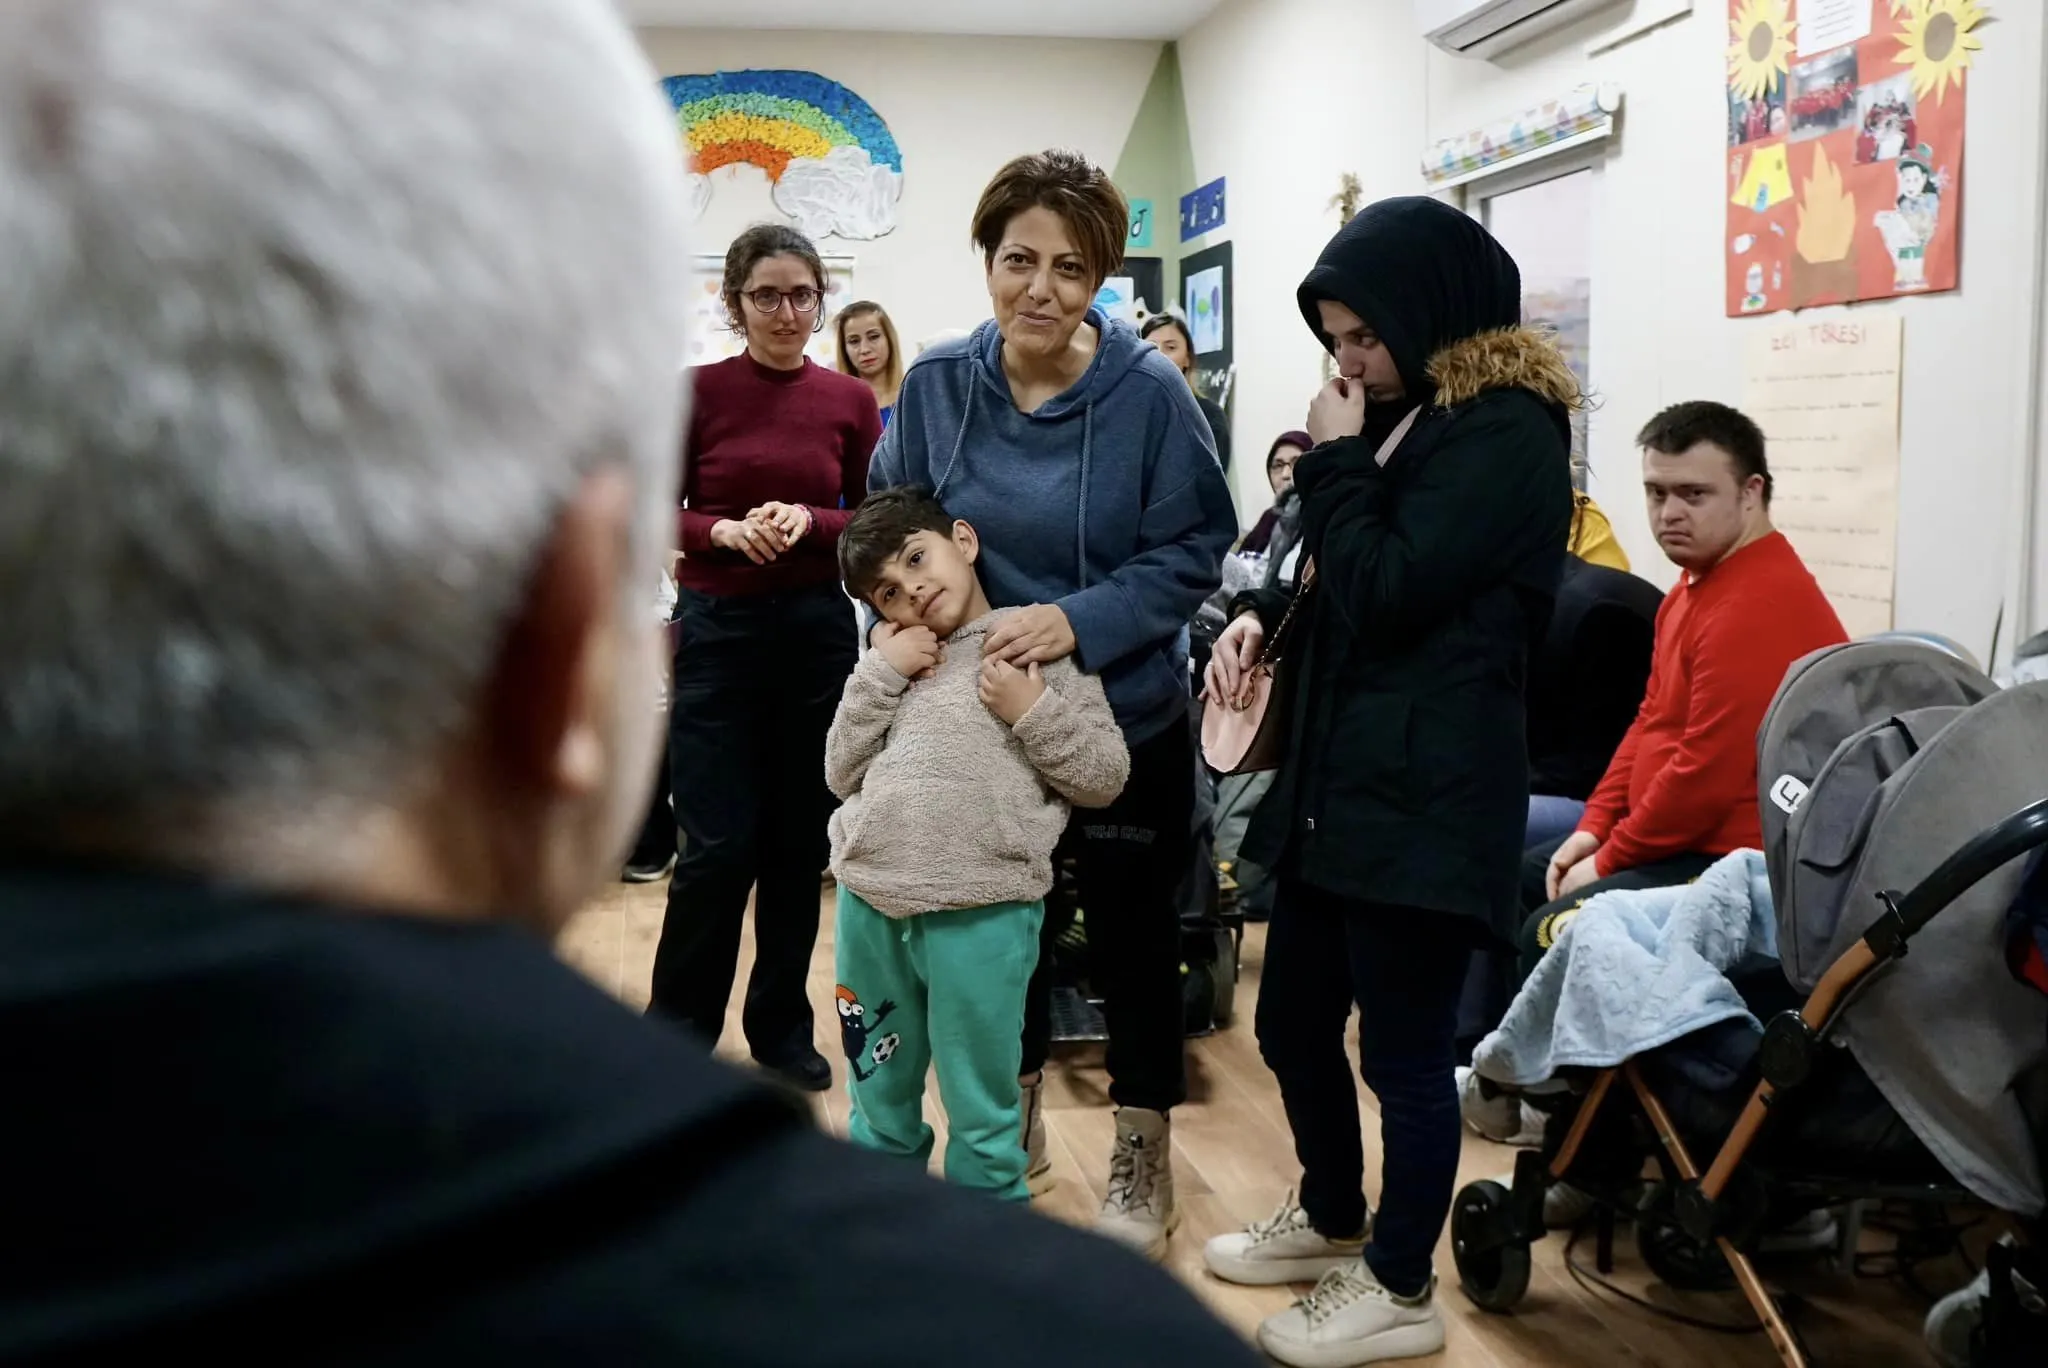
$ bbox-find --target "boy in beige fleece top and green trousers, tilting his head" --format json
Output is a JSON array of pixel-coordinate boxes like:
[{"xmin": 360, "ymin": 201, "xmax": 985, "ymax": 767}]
[{"xmin": 825, "ymin": 489, "xmax": 1130, "ymax": 1202}]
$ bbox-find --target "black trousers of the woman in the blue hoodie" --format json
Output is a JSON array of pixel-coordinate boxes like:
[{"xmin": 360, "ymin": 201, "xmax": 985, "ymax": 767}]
[{"xmin": 1022, "ymin": 723, "xmax": 1194, "ymax": 1112}]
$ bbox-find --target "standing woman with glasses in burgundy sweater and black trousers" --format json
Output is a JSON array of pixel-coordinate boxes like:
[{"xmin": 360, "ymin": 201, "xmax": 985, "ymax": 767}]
[{"xmin": 651, "ymin": 225, "xmax": 883, "ymax": 1089}]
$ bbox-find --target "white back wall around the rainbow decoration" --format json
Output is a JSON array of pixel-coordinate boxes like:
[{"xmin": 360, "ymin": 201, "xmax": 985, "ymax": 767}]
[{"xmin": 639, "ymin": 29, "xmax": 1159, "ymax": 352}]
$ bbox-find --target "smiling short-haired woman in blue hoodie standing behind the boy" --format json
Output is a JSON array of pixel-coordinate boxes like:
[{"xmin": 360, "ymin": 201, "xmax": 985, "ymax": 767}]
[{"xmin": 868, "ymin": 152, "xmax": 1237, "ymax": 1255}]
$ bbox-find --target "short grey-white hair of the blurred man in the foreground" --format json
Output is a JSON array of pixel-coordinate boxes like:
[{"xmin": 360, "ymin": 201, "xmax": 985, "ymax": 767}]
[{"xmin": 0, "ymin": 0, "xmax": 688, "ymax": 825}]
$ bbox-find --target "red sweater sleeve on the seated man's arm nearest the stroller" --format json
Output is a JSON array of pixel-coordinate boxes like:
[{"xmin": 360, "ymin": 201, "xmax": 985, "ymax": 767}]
[{"xmin": 1593, "ymin": 600, "xmax": 1784, "ymax": 877}]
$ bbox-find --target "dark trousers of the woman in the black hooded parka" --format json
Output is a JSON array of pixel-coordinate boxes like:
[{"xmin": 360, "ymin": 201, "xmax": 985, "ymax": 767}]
[{"xmin": 1257, "ymin": 879, "xmax": 1475, "ymax": 1296}]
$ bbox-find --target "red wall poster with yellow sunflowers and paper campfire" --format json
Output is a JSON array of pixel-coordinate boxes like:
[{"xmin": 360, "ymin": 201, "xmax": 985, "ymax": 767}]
[{"xmin": 1724, "ymin": 0, "xmax": 1985, "ymax": 317}]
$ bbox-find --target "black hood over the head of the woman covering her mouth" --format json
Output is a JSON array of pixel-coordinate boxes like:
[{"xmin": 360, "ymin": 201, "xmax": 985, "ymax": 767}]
[{"xmin": 1296, "ymin": 195, "xmax": 1522, "ymax": 403}]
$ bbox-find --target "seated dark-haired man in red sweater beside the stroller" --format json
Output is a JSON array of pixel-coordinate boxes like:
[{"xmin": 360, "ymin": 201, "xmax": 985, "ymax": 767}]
[{"xmin": 1524, "ymin": 401, "xmax": 1847, "ymax": 954}]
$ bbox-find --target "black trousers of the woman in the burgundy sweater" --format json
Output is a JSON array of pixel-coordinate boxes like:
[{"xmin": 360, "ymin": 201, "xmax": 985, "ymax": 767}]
[{"xmin": 649, "ymin": 584, "xmax": 858, "ymax": 1063}]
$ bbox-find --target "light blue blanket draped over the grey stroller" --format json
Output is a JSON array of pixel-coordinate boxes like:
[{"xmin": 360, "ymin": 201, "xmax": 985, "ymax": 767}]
[{"xmin": 1473, "ymin": 850, "xmax": 1778, "ymax": 1087}]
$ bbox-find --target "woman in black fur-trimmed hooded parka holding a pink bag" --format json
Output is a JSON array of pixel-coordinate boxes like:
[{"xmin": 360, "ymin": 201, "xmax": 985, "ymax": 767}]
[{"xmin": 1206, "ymin": 199, "xmax": 1581, "ymax": 1366}]
